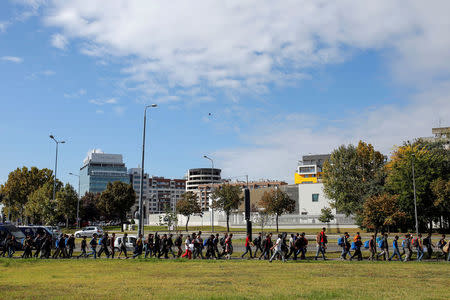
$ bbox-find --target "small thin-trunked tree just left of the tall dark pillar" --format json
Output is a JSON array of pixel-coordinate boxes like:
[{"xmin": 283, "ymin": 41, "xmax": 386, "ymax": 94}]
[{"xmin": 211, "ymin": 183, "xmax": 244, "ymax": 231}]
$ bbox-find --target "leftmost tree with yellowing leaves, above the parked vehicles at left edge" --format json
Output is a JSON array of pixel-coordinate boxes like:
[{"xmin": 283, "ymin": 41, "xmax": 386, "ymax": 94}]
[{"xmin": 0, "ymin": 167, "xmax": 54, "ymax": 220}]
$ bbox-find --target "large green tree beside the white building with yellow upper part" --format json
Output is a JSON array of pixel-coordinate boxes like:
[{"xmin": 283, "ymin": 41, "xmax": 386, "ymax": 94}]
[{"xmin": 323, "ymin": 141, "xmax": 386, "ymax": 217}]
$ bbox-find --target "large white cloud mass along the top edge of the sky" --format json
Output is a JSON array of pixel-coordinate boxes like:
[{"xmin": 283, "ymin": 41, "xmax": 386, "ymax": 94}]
[{"xmin": 38, "ymin": 0, "xmax": 450, "ymax": 96}]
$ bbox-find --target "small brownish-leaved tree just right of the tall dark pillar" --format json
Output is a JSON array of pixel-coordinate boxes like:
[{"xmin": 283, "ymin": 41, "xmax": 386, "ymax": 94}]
[{"xmin": 259, "ymin": 189, "xmax": 295, "ymax": 232}]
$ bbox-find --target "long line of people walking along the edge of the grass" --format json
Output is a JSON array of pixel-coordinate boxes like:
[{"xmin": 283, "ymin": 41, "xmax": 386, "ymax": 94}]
[{"xmin": 0, "ymin": 228, "xmax": 450, "ymax": 262}]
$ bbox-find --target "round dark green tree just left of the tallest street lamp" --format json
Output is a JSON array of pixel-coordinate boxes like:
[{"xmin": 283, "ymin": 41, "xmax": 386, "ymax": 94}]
[{"xmin": 97, "ymin": 181, "xmax": 136, "ymax": 228}]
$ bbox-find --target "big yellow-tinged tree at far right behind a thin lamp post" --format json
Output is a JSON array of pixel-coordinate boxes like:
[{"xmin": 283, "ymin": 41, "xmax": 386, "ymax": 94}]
[{"xmin": 386, "ymin": 139, "xmax": 450, "ymax": 231}]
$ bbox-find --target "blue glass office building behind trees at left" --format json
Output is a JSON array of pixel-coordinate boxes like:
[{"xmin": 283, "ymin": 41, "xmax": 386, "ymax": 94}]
[{"xmin": 80, "ymin": 152, "xmax": 130, "ymax": 196}]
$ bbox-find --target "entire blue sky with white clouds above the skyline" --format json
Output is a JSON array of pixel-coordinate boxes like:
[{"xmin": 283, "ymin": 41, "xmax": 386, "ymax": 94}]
[{"xmin": 0, "ymin": 0, "xmax": 450, "ymax": 184}]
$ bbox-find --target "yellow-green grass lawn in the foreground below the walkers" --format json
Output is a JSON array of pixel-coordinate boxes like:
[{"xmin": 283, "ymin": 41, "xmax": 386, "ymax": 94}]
[{"xmin": 0, "ymin": 259, "xmax": 450, "ymax": 299}]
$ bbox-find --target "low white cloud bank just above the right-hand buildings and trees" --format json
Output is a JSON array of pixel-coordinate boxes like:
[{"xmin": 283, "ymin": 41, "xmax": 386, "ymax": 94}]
[{"xmin": 214, "ymin": 82, "xmax": 450, "ymax": 182}]
